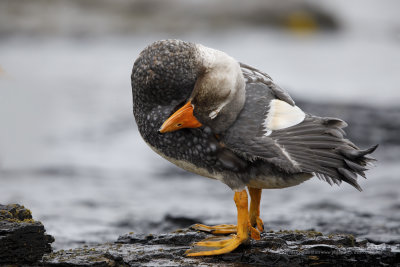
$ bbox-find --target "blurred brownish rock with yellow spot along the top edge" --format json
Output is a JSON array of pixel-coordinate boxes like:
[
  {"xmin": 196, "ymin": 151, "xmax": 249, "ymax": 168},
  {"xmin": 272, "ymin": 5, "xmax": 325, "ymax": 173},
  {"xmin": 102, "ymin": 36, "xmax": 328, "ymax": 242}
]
[{"xmin": 0, "ymin": 0, "xmax": 339, "ymax": 37}]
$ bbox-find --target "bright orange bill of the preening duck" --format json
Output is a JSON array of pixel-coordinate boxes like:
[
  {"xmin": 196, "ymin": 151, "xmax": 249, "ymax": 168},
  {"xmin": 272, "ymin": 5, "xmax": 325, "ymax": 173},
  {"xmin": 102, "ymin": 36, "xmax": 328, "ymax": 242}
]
[{"xmin": 159, "ymin": 101, "xmax": 202, "ymax": 133}]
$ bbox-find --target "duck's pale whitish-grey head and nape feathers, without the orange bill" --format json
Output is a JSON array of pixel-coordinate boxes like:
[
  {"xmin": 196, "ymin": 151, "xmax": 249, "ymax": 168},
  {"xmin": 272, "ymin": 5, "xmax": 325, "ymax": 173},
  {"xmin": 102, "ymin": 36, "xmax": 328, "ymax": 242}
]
[{"xmin": 191, "ymin": 45, "xmax": 245, "ymax": 133}]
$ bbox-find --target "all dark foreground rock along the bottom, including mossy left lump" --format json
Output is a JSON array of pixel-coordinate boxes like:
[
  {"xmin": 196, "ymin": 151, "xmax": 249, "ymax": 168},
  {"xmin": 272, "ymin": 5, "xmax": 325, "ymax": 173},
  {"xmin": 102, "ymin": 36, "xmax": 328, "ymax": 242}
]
[{"xmin": 0, "ymin": 204, "xmax": 400, "ymax": 266}]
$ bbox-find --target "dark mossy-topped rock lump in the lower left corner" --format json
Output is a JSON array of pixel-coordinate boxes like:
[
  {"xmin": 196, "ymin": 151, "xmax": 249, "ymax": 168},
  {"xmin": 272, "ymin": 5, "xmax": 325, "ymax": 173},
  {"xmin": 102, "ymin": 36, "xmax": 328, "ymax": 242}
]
[{"xmin": 0, "ymin": 204, "xmax": 54, "ymax": 265}]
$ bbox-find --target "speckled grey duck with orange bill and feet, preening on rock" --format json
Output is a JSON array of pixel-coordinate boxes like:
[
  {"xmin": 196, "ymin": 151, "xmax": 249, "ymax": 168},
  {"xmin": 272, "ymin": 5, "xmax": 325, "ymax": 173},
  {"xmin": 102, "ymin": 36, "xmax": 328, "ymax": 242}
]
[{"xmin": 131, "ymin": 39, "xmax": 377, "ymax": 256}]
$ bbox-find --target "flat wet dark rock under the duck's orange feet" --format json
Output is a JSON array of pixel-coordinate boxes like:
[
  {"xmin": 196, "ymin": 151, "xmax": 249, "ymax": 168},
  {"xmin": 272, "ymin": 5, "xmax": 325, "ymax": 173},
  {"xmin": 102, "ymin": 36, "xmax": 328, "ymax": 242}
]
[{"xmin": 42, "ymin": 229, "xmax": 400, "ymax": 266}]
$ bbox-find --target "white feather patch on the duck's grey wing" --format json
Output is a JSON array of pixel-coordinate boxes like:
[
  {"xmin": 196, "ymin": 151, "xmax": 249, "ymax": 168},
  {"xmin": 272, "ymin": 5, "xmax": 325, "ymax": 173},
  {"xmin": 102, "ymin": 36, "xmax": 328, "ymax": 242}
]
[{"xmin": 264, "ymin": 99, "xmax": 306, "ymax": 136}]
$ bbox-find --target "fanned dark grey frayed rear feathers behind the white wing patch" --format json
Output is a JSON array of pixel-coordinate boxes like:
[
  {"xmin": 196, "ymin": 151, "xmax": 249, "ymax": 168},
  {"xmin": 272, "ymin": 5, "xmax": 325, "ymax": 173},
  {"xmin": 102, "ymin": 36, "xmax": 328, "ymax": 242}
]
[{"xmin": 271, "ymin": 116, "xmax": 378, "ymax": 191}]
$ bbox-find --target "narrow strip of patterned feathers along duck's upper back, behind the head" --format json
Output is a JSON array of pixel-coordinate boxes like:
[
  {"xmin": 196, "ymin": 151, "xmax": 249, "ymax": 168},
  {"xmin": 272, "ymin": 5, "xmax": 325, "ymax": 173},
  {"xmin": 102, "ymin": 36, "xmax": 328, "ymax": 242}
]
[{"xmin": 239, "ymin": 62, "xmax": 295, "ymax": 106}]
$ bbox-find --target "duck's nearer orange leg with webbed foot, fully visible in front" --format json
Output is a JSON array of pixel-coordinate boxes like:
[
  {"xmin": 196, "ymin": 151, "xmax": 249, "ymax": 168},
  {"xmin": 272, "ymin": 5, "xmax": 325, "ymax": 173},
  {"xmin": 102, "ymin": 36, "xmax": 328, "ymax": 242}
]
[{"xmin": 186, "ymin": 190, "xmax": 251, "ymax": 256}]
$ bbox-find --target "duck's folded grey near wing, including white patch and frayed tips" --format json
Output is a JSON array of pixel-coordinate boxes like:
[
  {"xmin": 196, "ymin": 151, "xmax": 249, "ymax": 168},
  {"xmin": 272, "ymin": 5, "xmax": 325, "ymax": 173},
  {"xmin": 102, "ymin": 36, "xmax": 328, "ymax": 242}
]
[{"xmin": 224, "ymin": 83, "xmax": 376, "ymax": 190}]
